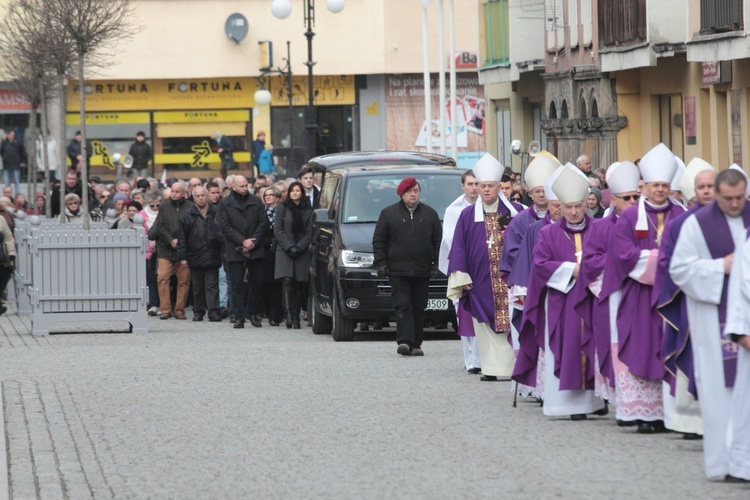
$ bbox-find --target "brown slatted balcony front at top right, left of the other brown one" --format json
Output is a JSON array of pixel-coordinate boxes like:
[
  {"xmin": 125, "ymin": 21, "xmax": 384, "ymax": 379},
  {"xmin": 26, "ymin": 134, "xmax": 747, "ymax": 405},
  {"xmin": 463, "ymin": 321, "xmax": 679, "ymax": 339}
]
[{"xmin": 599, "ymin": 0, "xmax": 646, "ymax": 47}]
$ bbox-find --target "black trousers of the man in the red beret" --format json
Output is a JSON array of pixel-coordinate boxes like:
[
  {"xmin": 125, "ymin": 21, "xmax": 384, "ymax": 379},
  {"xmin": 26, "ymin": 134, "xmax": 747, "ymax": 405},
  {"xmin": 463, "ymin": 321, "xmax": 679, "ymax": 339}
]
[{"xmin": 389, "ymin": 276, "xmax": 430, "ymax": 348}]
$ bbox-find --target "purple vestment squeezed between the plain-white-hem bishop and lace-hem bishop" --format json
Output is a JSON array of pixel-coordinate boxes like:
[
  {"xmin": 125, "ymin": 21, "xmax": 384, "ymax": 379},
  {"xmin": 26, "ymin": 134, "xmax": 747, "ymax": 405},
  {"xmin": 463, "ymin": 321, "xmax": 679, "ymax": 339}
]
[{"xmin": 574, "ymin": 211, "xmax": 618, "ymax": 387}]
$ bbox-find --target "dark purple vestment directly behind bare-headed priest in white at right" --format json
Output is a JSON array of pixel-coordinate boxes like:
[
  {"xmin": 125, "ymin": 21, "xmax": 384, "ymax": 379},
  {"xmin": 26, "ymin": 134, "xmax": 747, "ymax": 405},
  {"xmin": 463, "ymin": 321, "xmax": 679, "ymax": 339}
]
[{"xmin": 655, "ymin": 204, "xmax": 701, "ymax": 399}]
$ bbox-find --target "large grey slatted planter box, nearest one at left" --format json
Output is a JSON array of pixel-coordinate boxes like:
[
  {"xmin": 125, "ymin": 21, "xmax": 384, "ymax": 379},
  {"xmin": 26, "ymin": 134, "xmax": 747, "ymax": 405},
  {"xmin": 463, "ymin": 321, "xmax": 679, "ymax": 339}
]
[{"xmin": 28, "ymin": 225, "xmax": 148, "ymax": 335}]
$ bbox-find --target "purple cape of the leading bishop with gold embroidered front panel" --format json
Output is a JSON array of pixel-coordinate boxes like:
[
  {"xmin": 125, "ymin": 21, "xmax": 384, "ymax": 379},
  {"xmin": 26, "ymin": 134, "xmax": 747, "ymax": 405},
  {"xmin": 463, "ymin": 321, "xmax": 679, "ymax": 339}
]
[{"xmin": 448, "ymin": 201, "xmax": 510, "ymax": 331}]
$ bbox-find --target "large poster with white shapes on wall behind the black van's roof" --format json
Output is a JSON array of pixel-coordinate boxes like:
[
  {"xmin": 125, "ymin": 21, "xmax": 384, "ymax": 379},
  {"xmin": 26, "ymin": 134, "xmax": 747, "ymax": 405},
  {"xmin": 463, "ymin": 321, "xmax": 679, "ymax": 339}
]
[{"xmin": 386, "ymin": 72, "xmax": 486, "ymax": 168}]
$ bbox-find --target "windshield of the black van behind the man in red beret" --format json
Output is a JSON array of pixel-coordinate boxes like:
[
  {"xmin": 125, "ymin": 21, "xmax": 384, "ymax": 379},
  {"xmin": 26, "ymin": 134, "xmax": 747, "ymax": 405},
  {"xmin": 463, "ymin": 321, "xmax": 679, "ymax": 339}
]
[{"xmin": 341, "ymin": 171, "xmax": 462, "ymax": 224}]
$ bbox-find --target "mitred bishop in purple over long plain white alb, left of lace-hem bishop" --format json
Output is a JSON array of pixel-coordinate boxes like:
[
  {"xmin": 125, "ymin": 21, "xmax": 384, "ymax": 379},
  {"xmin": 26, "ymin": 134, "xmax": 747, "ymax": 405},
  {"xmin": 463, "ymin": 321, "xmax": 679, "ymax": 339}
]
[{"xmin": 514, "ymin": 165, "xmax": 607, "ymax": 420}]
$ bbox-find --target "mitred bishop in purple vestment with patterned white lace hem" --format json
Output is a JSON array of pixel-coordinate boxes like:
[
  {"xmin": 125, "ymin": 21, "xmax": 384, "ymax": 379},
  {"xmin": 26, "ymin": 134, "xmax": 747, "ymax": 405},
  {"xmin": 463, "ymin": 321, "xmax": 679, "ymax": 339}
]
[{"xmin": 599, "ymin": 144, "xmax": 684, "ymax": 434}]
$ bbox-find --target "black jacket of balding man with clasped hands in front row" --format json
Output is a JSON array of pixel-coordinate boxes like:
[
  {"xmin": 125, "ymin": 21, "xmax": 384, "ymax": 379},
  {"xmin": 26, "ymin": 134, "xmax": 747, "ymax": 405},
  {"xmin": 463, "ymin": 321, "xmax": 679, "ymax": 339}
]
[{"xmin": 216, "ymin": 191, "xmax": 268, "ymax": 262}]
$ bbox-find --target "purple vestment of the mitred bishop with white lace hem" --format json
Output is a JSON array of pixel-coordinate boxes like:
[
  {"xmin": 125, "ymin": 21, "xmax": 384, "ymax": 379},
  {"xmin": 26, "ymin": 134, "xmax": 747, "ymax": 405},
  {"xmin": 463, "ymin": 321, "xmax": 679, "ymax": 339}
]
[{"xmin": 599, "ymin": 201, "xmax": 685, "ymax": 380}]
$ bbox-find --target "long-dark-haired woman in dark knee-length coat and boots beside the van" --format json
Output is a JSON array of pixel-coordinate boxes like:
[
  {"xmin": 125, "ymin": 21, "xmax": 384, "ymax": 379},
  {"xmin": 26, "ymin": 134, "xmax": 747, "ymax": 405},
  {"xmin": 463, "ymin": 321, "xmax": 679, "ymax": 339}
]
[{"xmin": 273, "ymin": 182, "xmax": 312, "ymax": 329}]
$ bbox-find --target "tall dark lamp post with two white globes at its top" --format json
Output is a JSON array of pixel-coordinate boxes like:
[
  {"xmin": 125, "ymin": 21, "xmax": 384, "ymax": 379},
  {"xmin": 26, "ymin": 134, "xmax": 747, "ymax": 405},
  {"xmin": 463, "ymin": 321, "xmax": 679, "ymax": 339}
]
[{"xmin": 271, "ymin": 0, "xmax": 344, "ymax": 166}]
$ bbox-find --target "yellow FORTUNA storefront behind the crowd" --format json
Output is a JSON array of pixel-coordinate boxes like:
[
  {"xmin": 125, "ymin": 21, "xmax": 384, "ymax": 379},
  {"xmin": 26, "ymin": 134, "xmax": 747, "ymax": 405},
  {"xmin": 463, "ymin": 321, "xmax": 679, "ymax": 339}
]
[{"xmin": 66, "ymin": 76, "xmax": 355, "ymax": 178}]
